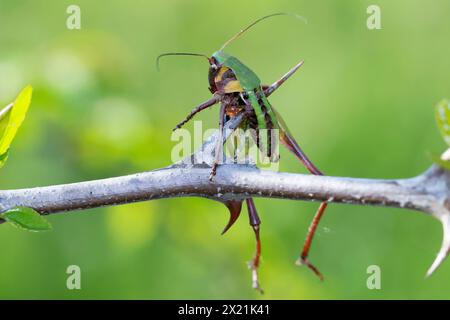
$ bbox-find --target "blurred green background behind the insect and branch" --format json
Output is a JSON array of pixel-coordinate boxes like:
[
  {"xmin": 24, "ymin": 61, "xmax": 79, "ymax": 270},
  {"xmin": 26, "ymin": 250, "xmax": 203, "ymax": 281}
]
[{"xmin": 0, "ymin": 0, "xmax": 450, "ymax": 299}]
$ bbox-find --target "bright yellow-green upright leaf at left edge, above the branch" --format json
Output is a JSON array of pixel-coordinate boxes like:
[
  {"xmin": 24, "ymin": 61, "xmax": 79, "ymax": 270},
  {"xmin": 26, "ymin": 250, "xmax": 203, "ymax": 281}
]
[{"xmin": 0, "ymin": 86, "xmax": 33, "ymax": 168}]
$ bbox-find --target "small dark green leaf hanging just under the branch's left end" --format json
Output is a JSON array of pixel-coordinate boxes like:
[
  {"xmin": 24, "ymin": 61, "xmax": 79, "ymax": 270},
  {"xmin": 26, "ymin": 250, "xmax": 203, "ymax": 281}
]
[{"xmin": 0, "ymin": 207, "xmax": 52, "ymax": 231}]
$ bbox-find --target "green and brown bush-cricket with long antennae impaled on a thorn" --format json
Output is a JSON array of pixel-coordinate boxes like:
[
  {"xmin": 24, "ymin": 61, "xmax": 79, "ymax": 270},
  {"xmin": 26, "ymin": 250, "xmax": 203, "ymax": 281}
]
[{"xmin": 157, "ymin": 13, "xmax": 327, "ymax": 292}]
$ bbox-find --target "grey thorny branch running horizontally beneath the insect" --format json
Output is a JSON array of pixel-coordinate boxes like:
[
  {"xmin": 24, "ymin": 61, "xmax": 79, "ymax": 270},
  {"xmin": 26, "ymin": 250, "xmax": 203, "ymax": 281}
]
[{"xmin": 0, "ymin": 117, "xmax": 450, "ymax": 275}]
